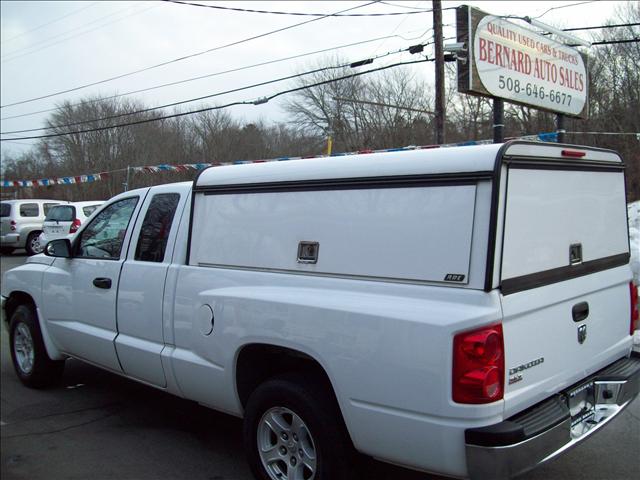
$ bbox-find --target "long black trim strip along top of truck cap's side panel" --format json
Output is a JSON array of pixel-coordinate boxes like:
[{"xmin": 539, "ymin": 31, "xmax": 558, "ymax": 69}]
[{"xmin": 194, "ymin": 171, "xmax": 493, "ymax": 195}]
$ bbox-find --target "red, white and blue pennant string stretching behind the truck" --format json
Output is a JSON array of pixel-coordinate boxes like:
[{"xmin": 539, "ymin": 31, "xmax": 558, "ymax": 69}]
[{"xmin": 0, "ymin": 132, "xmax": 558, "ymax": 187}]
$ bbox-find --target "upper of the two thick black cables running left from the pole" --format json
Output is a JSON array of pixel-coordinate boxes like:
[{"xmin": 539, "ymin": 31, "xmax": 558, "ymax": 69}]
[{"xmin": 0, "ymin": 42, "xmax": 433, "ymax": 135}]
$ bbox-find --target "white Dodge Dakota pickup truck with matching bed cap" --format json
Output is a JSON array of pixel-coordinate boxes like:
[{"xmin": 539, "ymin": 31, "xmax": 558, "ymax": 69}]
[{"xmin": 2, "ymin": 142, "xmax": 640, "ymax": 480}]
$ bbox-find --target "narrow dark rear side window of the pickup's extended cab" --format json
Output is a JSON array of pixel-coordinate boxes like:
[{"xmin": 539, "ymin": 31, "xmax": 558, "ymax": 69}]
[{"xmin": 135, "ymin": 193, "xmax": 180, "ymax": 262}]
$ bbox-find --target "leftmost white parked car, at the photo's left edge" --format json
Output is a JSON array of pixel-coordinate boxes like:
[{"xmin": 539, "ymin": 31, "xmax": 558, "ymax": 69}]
[{"xmin": 0, "ymin": 199, "xmax": 68, "ymax": 255}]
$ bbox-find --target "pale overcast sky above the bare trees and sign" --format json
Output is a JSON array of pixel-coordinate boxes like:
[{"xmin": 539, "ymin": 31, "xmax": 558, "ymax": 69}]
[{"xmin": 0, "ymin": 0, "xmax": 627, "ymax": 157}]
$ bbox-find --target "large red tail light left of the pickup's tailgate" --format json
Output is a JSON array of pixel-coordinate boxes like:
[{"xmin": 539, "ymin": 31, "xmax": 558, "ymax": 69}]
[{"xmin": 453, "ymin": 324, "xmax": 504, "ymax": 404}]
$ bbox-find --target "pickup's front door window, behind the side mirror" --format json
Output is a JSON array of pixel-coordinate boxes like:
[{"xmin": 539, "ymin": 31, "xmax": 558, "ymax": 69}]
[{"xmin": 76, "ymin": 197, "xmax": 138, "ymax": 260}]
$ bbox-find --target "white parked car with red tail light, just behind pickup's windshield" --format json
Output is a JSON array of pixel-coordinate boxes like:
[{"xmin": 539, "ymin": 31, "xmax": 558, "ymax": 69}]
[{"xmin": 34, "ymin": 200, "xmax": 104, "ymax": 253}]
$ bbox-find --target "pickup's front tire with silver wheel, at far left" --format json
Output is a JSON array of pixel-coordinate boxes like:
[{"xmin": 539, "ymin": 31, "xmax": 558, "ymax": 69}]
[{"xmin": 9, "ymin": 305, "xmax": 64, "ymax": 388}]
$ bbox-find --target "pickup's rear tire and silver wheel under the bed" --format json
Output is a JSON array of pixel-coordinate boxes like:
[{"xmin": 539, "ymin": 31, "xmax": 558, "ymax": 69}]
[{"xmin": 244, "ymin": 374, "xmax": 355, "ymax": 480}]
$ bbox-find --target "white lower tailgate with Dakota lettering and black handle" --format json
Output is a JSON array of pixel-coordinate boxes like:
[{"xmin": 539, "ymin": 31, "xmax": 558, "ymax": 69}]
[{"xmin": 502, "ymin": 266, "xmax": 632, "ymax": 417}]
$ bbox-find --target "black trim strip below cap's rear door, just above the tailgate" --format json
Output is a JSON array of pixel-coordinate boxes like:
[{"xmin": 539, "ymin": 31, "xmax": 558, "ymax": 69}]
[{"xmin": 501, "ymin": 253, "xmax": 630, "ymax": 295}]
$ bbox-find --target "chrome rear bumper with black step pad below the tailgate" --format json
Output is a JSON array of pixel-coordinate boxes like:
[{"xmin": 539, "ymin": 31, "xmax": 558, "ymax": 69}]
[{"xmin": 465, "ymin": 353, "xmax": 640, "ymax": 480}]
